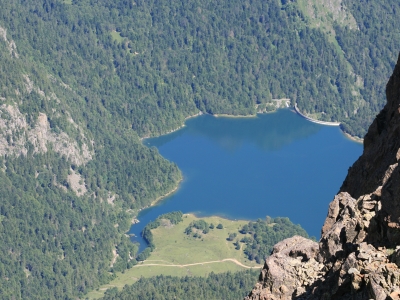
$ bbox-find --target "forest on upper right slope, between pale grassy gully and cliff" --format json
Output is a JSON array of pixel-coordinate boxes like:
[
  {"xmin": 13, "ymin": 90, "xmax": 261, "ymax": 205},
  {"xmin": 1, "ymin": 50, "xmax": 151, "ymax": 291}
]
[{"xmin": 335, "ymin": 0, "xmax": 400, "ymax": 137}]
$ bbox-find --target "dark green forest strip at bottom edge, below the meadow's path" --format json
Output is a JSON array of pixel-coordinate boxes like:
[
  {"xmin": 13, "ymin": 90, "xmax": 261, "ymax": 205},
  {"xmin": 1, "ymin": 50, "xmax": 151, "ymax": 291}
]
[{"xmin": 102, "ymin": 270, "xmax": 260, "ymax": 300}]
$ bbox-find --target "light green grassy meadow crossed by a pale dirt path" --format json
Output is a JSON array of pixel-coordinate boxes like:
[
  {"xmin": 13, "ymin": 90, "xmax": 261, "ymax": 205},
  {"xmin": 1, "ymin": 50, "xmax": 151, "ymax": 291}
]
[{"xmin": 87, "ymin": 214, "xmax": 261, "ymax": 299}]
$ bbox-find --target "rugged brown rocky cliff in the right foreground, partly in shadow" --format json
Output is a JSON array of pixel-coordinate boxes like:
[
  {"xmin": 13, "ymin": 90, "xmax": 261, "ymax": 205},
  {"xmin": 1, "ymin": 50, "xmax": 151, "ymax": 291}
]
[{"xmin": 245, "ymin": 57, "xmax": 400, "ymax": 300}]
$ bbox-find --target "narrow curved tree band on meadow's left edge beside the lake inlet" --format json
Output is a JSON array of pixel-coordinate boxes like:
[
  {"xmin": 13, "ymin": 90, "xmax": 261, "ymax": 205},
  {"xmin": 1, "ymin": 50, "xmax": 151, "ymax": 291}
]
[{"xmin": 136, "ymin": 211, "xmax": 183, "ymax": 261}]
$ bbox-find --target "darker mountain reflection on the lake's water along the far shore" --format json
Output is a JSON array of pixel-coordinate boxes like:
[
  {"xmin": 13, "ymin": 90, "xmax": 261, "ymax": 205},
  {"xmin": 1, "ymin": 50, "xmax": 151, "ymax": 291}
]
[{"xmin": 145, "ymin": 110, "xmax": 321, "ymax": 151}]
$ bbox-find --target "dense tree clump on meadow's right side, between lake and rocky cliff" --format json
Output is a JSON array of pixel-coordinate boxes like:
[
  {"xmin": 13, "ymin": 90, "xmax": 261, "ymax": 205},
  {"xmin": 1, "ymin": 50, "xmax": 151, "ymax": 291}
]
[{"xmin": 240, "ymin": 217, "xmax": 308, "ymax": 264}]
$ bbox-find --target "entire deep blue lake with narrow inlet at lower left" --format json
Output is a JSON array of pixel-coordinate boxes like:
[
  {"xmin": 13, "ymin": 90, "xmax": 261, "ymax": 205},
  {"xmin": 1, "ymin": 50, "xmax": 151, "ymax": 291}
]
[{"xmin": 130, "ymin": 109, "xmax": 362, "ymax": 249}]
